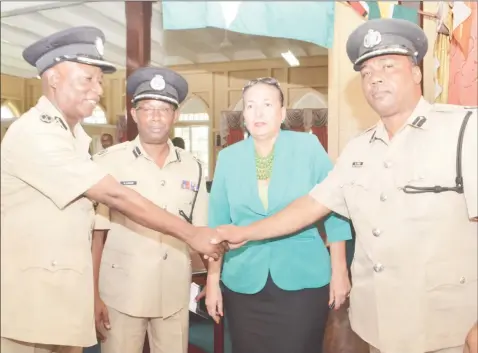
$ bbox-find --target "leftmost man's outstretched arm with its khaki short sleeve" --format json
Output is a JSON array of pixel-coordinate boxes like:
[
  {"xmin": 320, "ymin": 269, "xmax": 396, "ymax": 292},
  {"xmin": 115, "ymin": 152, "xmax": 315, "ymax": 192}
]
[{"xmin": 7, "ymin": 126, "xmax": 224, "ymax": 259}]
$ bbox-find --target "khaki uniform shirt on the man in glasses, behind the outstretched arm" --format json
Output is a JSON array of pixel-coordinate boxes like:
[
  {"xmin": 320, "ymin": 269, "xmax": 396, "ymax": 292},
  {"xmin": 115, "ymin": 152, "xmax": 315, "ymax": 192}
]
[{"xmin": 94, "ymin": 138, "xmax": 208, "ymax": 317}]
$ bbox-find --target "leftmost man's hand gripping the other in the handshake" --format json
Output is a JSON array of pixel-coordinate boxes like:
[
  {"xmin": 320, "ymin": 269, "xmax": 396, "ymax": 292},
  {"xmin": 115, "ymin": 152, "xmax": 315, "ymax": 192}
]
[{"xmin": 188, "ymin": 227, "xmax": 228, "ymax": 261}]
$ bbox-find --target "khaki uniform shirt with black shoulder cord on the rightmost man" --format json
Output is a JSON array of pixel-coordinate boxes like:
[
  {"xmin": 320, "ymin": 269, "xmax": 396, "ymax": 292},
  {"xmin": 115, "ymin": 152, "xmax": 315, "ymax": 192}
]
[{"xmin": 311, "ymin": 98, "xmax": 478, "ymax": 353}]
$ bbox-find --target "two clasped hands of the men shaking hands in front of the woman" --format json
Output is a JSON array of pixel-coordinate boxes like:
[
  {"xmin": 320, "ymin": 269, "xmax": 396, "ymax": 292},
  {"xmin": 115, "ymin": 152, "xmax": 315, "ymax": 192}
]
[{"xmin": 187, "ymin": 225, "xmax": 249, "ymax": 261}]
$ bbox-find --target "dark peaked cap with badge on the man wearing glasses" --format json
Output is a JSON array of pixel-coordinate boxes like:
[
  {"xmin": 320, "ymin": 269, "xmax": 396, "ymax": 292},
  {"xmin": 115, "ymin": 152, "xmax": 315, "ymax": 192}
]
[{"xmin": 126, "ymin": 67, "xmax": 188, "ymax": 107}]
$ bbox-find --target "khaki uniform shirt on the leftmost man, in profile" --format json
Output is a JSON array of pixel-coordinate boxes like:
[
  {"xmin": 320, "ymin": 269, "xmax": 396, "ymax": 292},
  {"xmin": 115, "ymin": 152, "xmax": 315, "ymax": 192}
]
[{"xmin": 1, "ymin": 97, "xmax": 106, "ymax": 346}]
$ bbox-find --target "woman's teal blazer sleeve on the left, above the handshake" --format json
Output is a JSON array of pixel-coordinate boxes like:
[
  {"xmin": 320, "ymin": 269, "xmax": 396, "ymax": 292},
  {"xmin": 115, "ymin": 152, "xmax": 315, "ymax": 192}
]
[{"xmin": 208, "ymin": 152, "xmax": 232, "ymax": 228}]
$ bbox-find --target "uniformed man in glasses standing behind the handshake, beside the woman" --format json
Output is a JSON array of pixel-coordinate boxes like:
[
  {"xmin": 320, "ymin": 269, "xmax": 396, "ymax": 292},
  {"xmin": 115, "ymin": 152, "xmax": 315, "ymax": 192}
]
[{"xmin": 93, "ymin": 67, "xmax": 208, "ymax": 353}]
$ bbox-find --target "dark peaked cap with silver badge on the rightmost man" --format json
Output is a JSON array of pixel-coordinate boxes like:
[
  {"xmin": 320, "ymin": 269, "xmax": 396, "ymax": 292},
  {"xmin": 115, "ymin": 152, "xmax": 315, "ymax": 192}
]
[{"xmin": 347, "ymin": 18, "xmax": 428, "ymax": 71}]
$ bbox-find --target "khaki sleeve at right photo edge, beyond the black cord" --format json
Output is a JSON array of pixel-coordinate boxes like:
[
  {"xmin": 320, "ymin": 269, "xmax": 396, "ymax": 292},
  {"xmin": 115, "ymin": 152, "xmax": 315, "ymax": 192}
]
[{"xmin": 462, "ymin": 109, "xmax": 478, "ymax": 219}]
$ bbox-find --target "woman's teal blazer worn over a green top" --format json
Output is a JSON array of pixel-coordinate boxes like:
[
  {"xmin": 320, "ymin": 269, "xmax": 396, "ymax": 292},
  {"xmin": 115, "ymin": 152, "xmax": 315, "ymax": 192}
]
[{"xmin": 209, "ymin": 131, "xmax": 351, "ymax": 294}]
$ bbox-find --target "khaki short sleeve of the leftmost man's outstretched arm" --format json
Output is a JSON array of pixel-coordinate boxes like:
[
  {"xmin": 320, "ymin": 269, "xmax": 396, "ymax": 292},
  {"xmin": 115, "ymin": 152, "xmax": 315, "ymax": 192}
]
[{"xmin": 7, "ymin": 126, "xmax": 107, "ymax": 209}]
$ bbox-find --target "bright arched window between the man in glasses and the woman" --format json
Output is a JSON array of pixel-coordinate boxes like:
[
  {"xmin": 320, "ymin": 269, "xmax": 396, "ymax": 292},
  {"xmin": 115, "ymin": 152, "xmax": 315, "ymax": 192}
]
[{"xmin": 174, "ymin": 97, "xmax": 210, "ymax": 179}]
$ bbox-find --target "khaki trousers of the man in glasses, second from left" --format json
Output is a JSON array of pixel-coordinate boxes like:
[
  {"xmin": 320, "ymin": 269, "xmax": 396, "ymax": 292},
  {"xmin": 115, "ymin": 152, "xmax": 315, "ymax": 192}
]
[{"xmin": 101, "ymin": 307, "xmax": 189, "ymax": 353}]
